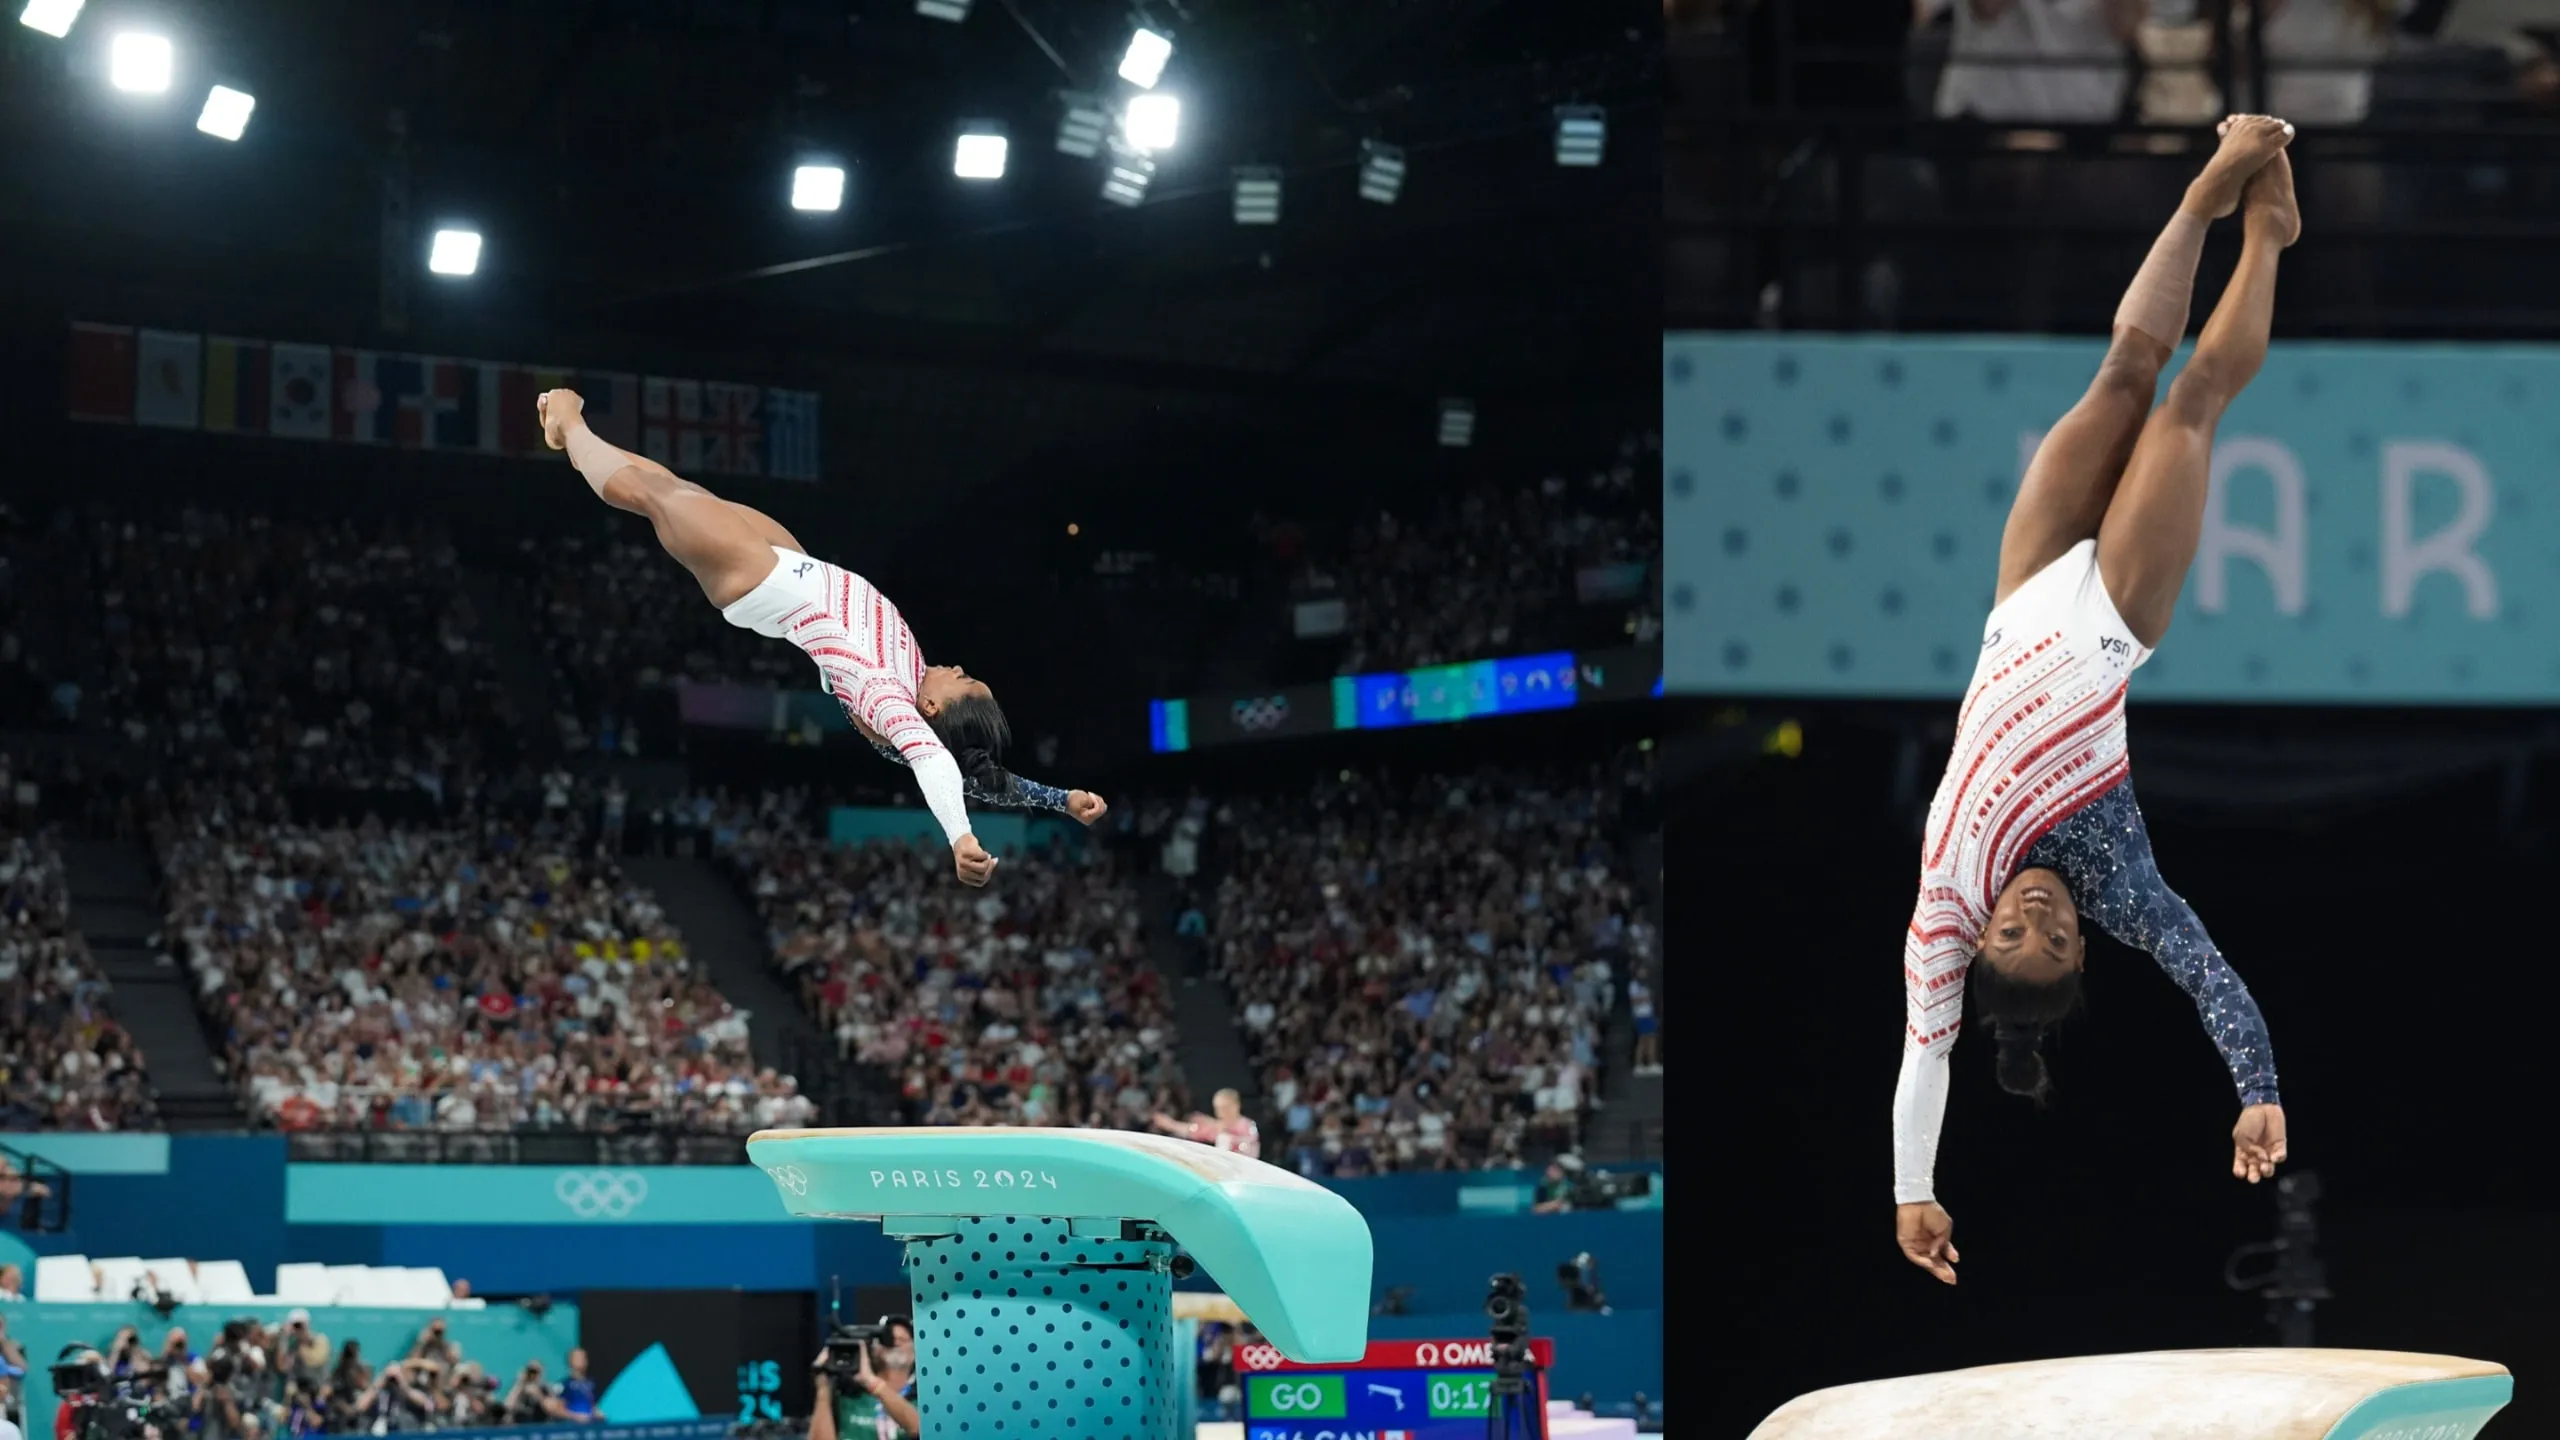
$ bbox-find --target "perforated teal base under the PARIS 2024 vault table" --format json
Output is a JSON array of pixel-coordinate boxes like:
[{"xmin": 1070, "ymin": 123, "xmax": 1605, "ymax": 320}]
[{"xmin": 891, "ymin": 1217, "xmax": 1193, "ymax": 1440}]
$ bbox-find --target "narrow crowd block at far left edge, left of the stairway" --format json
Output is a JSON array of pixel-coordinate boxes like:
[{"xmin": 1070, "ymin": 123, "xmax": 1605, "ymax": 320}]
[{"xmin": 0, "ymin": 814, "xmax": 156, "ymax": 1130}]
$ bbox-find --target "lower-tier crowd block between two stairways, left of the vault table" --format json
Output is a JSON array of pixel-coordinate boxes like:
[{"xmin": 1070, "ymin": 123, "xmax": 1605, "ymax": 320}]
[{"xmin": 159, "ymin": 817, "xmax": 809, "ymax": 1133}]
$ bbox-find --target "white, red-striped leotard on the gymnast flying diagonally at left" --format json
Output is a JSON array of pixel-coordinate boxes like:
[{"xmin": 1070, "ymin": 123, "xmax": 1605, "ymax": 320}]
[{"xmin": 722, "ymin": 546, "xmax": 1068, "ymax": 843}]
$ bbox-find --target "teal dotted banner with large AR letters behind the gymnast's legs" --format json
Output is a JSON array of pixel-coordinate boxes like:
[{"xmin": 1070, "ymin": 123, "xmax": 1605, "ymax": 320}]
[{"xmin": 1661, "ymin": 333, "xmax": 2560, "ymax": 705}]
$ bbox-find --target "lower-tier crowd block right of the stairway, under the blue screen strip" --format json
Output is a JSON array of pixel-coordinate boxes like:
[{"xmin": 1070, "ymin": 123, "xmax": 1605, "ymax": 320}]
[{"xmin": 1196, "ymin": 766, "xmax": 1654, "ymax": 1176}]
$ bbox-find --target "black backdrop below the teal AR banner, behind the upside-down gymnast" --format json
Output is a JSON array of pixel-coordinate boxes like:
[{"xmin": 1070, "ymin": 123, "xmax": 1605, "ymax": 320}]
[{"xmin": 1664, "ymin": 691, "xmax": 2560, "ymax": 1435}]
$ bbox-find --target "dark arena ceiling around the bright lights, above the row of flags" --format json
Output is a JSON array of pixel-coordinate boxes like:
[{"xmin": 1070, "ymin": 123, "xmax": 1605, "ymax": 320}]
[{"xmin": 0, "ymin": 0, "xmax": 1659, "ymax": 400}]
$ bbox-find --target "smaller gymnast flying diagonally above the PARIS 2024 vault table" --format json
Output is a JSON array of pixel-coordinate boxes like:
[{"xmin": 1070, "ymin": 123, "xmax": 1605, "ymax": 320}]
[{"xmin": 535, "ymin": 389, "xmax": 1106, "ymax": 884}]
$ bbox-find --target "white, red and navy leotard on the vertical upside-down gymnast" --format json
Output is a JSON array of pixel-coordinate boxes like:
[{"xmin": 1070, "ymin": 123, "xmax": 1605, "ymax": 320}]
[{"xmin": 1894, "ymin": 541, "xmax": 2278, "ymax": 1204}]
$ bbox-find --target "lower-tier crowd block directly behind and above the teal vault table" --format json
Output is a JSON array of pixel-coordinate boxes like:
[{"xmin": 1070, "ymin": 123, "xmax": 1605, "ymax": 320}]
[{"xmin": 696, "ymin": 794, "xmax": 1188, "ymax": 1130}]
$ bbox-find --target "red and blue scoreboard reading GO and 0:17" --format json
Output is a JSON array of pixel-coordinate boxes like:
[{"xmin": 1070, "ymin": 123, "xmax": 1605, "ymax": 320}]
[{"xmin": 1236, "ymin": 1338, "xmax": 1556, "ymax": 1440}]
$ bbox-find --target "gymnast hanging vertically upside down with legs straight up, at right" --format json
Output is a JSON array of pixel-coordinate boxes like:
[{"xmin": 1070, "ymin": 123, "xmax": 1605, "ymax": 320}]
[{"xmin": 1894, "ymin": 115, "xmax": 2301, "ymax": 1284}]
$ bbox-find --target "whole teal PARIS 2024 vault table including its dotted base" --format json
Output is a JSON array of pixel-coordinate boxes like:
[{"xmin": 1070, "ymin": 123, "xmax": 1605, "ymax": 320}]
[{"xmin": 748, "ymin": 1127, "xmax": 1370, "ymax": 1440}]
